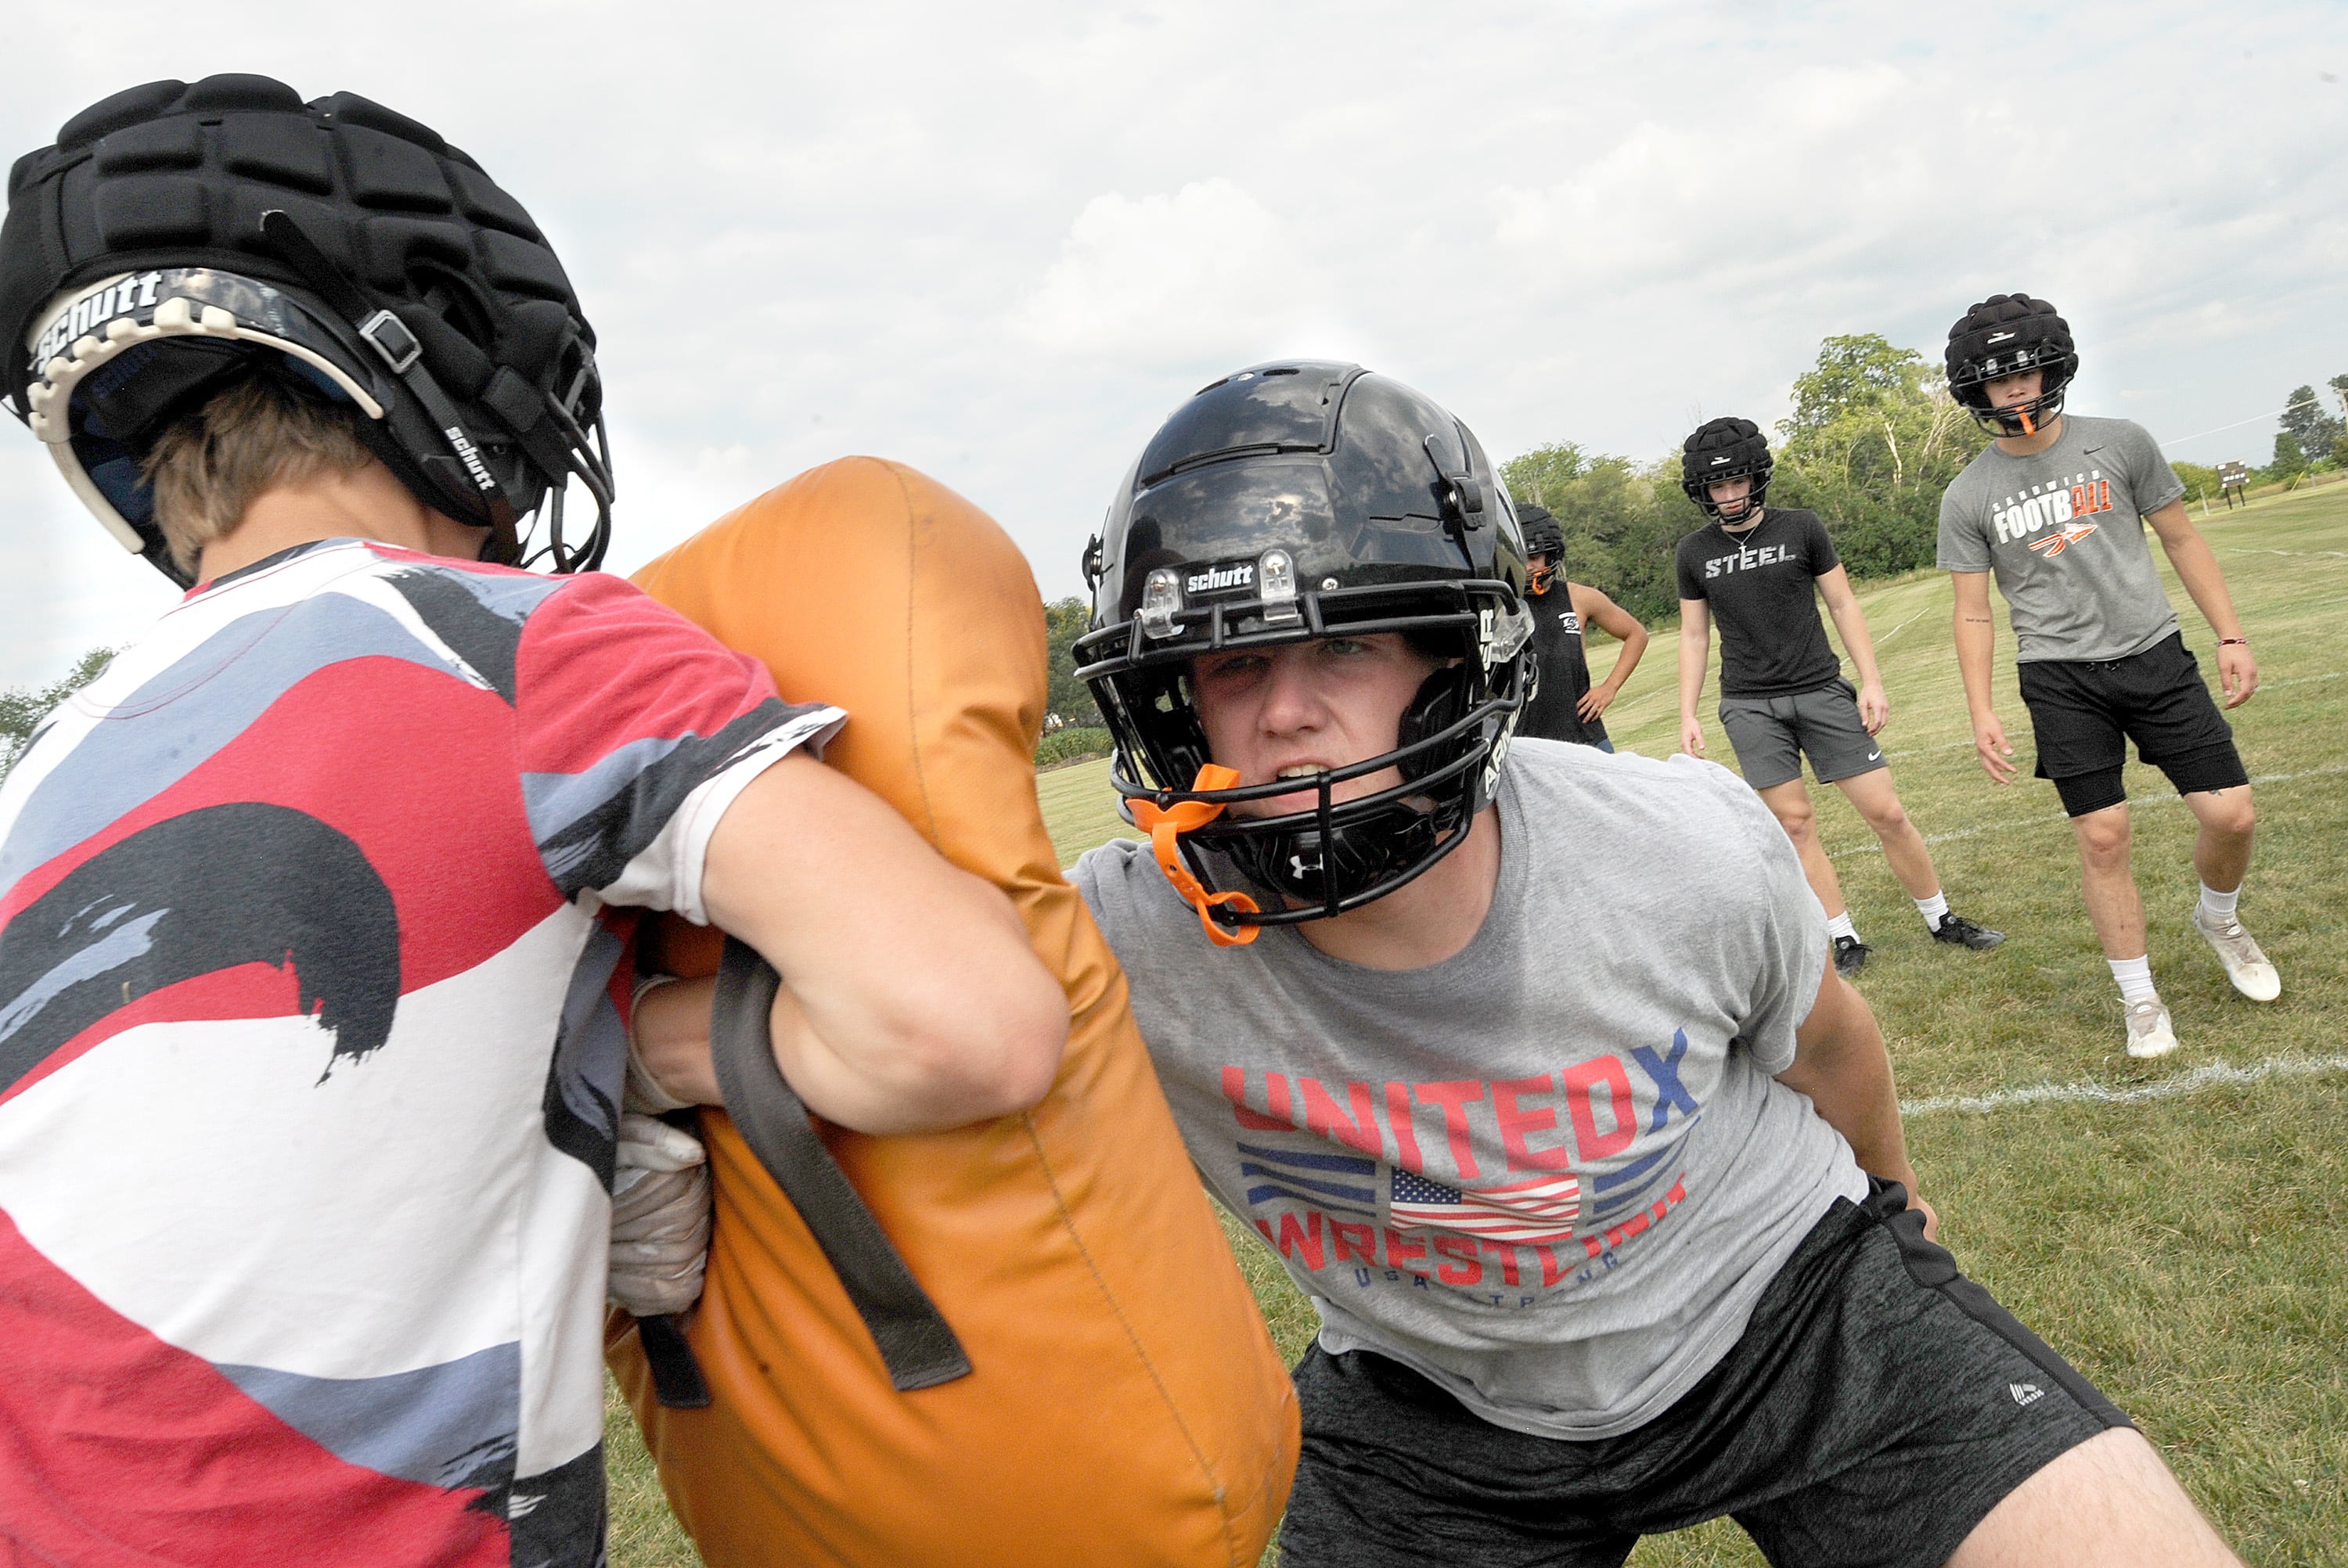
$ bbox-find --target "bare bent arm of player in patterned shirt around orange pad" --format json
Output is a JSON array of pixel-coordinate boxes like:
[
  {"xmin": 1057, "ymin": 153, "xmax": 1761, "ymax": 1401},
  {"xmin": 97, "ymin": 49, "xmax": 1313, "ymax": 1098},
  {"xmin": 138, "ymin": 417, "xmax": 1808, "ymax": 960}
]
[{"xmin": 636, "ymin": 756, "xmax": 1068, "ymax": 1134}]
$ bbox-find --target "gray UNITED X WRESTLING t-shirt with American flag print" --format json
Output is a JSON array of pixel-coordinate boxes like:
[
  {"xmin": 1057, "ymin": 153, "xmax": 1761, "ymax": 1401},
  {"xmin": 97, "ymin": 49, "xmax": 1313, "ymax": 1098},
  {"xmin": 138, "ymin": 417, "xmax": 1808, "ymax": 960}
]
[{"xmin": 1075, "ymin": 739, "xmax": 1867, "ymax": 1439}]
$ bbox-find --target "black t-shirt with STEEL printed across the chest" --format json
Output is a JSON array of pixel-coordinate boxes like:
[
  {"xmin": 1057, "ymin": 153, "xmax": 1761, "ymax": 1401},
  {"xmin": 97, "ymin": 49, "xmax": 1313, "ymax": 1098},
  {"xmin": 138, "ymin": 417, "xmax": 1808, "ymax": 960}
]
[{"xmin": 1679, "ymin": 507, "xmax": 1843, "ymax": 697}]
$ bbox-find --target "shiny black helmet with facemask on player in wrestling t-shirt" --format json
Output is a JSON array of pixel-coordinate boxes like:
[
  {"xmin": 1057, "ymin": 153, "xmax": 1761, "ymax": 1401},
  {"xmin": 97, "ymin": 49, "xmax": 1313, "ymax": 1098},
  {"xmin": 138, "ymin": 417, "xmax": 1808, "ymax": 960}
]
[{"xmin": 1075, "ymin": 359, "xmax": 1533, "ymax": 944}]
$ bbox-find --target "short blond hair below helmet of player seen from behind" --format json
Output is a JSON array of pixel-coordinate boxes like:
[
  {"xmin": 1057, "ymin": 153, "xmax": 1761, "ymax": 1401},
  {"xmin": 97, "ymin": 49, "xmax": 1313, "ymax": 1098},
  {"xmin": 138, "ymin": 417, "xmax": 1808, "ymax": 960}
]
[{"xmin": 141, "ymin": 376, "xmax": 373, "ymax": 573}]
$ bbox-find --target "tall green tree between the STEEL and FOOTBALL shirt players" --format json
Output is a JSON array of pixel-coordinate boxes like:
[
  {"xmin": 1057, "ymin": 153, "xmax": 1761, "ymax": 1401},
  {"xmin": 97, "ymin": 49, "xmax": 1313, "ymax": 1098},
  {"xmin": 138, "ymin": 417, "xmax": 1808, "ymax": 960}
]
[{"xmin": 1770, "ymin": 333, "xmax": 1989, "ymax": 577}]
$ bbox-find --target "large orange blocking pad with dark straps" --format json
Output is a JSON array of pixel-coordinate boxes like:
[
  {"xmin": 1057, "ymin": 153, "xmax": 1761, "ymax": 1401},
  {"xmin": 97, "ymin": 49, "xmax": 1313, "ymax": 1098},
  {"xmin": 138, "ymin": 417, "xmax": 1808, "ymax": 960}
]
[{"xmin": 610, "ymin": 458, "xmax": 1296, "ymax": 1568}]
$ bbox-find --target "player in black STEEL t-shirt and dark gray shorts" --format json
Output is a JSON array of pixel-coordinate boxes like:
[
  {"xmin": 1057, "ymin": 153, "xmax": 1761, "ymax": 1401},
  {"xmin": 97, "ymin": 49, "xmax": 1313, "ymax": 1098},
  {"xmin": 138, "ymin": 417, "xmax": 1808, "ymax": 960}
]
[{"xmin": 1679, "ymin": 418, "xmax": 2005, "ymax": 976}]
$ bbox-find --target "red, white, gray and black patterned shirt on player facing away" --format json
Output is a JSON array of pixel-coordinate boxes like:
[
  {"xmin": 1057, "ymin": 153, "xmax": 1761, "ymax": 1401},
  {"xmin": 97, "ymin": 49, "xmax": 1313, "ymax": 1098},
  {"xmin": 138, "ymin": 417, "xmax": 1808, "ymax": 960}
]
[{"xmin": 0, "ymin": 540, "xmax": 841, "ymax": 1568}]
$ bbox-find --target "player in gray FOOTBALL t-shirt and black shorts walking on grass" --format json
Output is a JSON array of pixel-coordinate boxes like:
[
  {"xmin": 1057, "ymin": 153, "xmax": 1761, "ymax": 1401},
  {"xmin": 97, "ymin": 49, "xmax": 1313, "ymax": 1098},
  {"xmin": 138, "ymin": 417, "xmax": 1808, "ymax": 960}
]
[{"xmin": 1939, "ymin": 293, "xmax": 2282, "ymax": 1056}]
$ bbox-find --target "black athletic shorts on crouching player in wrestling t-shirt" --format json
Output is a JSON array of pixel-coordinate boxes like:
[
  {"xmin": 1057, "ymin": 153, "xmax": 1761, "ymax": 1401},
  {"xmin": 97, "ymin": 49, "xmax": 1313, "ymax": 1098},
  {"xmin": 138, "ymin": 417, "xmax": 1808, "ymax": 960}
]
[{"xmin": 1280, "ymin": 1183, "xmax": 2127, "ymax": 1568}]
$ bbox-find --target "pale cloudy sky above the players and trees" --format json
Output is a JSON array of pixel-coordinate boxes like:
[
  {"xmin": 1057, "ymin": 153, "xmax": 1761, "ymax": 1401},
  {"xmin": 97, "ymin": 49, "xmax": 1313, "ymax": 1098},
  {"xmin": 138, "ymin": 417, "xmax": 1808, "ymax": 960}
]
[{"xmin": 0, "ymin": 0, "xmax": 2348, "ymax": 683}]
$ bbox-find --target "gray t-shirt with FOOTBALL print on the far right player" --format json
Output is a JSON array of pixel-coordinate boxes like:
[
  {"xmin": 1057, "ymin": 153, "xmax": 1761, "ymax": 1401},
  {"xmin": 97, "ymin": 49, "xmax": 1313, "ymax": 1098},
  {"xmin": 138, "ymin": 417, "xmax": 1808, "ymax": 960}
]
[{"xmin": 1939, "ymin": 413, "xmax": 2186, "ymax": 662}]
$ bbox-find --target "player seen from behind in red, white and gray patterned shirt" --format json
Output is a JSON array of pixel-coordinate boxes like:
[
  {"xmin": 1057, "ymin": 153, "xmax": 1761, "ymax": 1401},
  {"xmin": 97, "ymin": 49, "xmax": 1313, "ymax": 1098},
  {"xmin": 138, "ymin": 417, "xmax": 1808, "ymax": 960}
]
[{"xmin": 0, "ymin": 75, "xmax": 1066, "ymax": 1568}]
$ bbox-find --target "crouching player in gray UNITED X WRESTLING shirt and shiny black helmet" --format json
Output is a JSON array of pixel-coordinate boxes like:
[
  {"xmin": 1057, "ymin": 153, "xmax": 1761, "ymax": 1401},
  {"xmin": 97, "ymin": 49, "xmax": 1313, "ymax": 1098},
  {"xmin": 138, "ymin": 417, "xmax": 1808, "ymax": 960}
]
[{"xmin": 1073, "ymin": 361, "xmax": 2233, "ymax": 1568}]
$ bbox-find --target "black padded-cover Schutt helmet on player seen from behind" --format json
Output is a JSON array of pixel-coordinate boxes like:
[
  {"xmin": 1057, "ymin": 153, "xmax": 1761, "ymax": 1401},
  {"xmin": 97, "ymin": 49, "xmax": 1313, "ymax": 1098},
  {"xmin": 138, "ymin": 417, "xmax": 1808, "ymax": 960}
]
[{"xmin": 0, "ymin": 75, "xmax": 613, "ymax": 587}]
